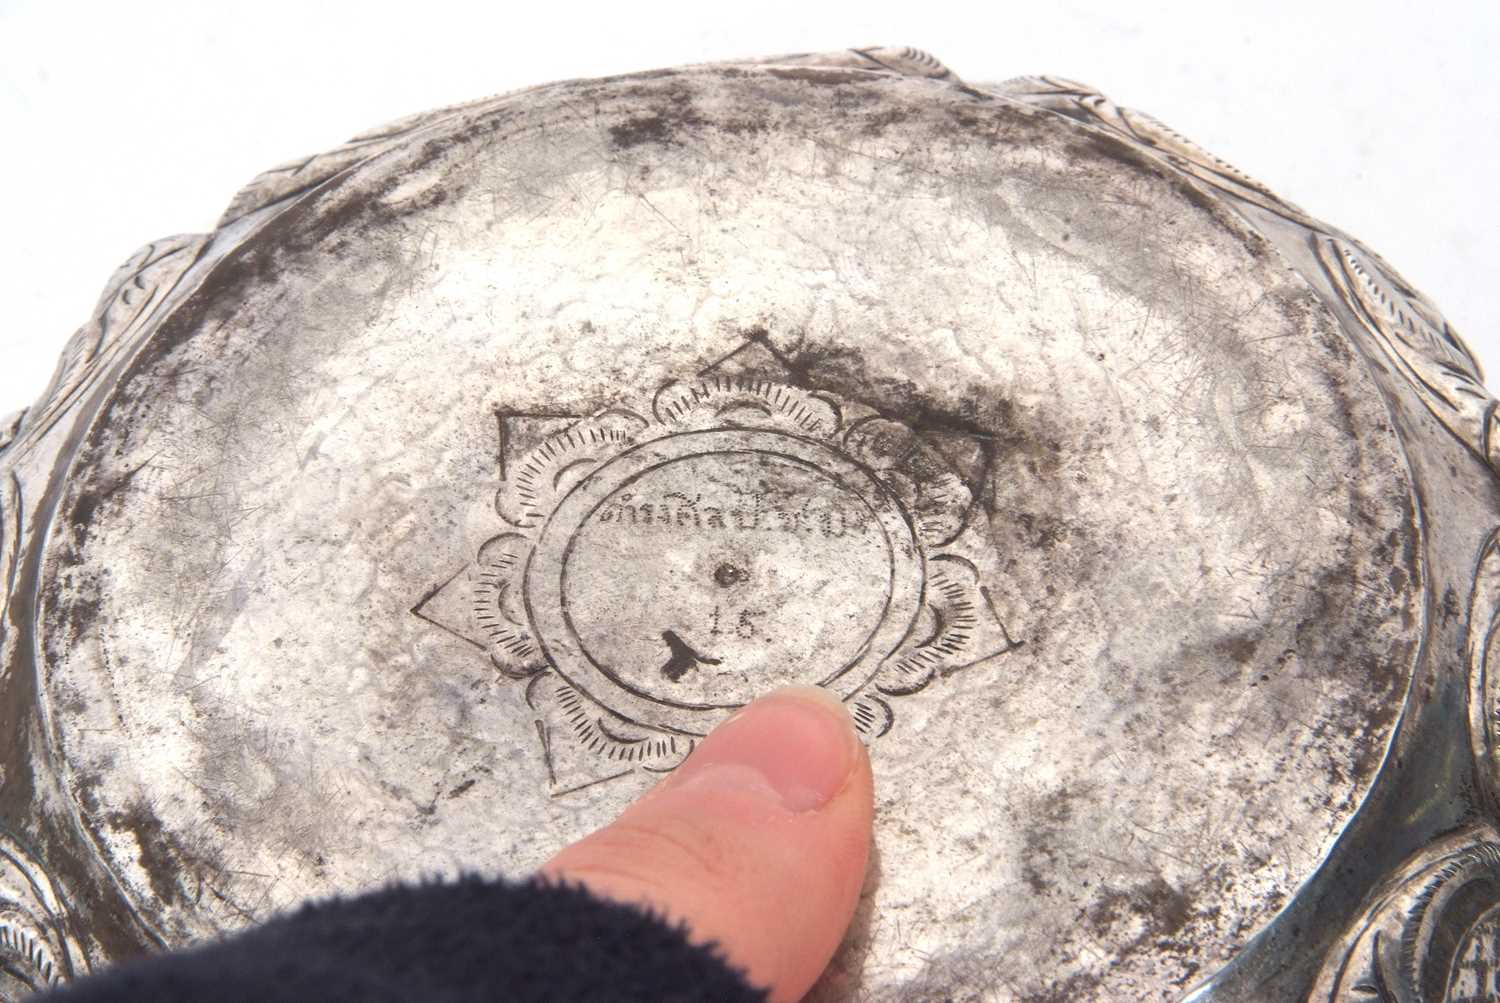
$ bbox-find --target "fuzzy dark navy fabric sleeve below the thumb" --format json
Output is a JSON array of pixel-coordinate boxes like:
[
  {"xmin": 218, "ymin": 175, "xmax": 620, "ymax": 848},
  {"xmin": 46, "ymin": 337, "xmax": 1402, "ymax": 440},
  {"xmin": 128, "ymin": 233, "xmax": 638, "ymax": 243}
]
[{"xmin": 33, "ymin": 877, "xmax": 767, "ymax": 1003}]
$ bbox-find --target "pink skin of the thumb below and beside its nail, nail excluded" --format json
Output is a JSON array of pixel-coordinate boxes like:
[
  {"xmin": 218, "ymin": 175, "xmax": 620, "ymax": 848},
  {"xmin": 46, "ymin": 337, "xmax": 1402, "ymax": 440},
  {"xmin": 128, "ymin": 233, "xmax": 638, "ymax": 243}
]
[{"xmin": 542, "ymin": 748, "xmax": 875, "ymax": 1003}]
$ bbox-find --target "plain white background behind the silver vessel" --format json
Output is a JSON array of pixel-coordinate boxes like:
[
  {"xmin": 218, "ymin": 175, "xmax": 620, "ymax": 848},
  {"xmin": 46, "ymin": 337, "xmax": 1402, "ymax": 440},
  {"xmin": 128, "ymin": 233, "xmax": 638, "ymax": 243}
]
[{"xmin": 0, "ymin": 0, "xmax": 1500, "ymax": 414}]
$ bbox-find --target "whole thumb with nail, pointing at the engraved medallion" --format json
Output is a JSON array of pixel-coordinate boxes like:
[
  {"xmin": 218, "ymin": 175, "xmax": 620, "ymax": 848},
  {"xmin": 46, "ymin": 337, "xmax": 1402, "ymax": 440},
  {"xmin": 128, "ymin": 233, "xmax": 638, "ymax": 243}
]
[{"xmin": 542, "ymin": 687, "xmax": 873, "ymax": 1003}]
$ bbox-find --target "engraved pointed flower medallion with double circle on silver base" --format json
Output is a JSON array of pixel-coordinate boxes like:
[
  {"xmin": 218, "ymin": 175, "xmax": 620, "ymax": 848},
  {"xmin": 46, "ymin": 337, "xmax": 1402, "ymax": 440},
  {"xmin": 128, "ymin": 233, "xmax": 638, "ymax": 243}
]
[{"xmin": 411, "ymin": 331, "xmax": 1019, "ymax": 796}]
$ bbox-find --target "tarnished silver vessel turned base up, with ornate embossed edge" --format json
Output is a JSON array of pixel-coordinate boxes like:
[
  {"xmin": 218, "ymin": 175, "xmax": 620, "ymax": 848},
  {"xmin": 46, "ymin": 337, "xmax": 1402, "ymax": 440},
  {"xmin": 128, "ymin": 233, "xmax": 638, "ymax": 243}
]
[{"xmin": 0, "ymin": 49, "xmax": 1500, "ymax": 1003}]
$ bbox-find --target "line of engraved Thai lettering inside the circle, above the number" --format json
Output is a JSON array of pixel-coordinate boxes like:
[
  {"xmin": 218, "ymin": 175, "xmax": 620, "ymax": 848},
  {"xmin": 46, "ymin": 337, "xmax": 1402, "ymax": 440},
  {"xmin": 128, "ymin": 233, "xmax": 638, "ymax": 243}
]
[{"xmin": 593, "ymin": 492, "xmax": 873, "ymax": 540}]
